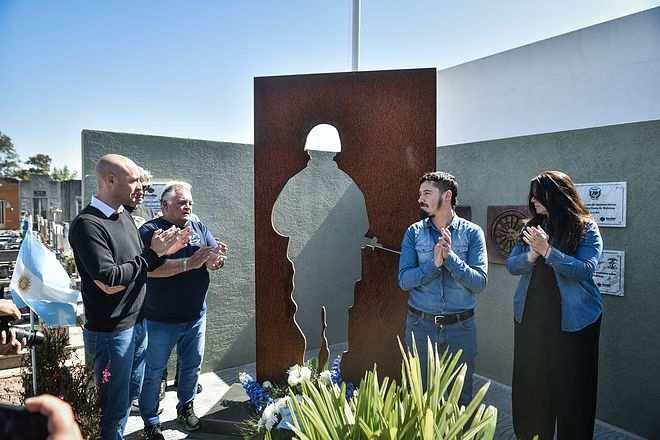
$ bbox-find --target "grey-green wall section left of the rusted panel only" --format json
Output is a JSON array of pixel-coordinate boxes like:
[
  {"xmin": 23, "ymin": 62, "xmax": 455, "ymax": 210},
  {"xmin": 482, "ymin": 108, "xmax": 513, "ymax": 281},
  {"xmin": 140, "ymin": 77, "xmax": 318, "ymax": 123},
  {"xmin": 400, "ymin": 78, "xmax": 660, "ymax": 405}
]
[{"xmin": 82, "ymin": 130, "xmax": 255, "ymax": 371}]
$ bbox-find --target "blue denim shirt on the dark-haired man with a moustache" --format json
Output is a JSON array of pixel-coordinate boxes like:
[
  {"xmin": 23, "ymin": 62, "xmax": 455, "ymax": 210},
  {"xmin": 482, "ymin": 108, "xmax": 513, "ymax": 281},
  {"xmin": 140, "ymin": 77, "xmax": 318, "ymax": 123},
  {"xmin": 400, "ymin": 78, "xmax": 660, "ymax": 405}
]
[{"xmin": 399, "ymin": 215, "xmax": 488, "ymax": 315}]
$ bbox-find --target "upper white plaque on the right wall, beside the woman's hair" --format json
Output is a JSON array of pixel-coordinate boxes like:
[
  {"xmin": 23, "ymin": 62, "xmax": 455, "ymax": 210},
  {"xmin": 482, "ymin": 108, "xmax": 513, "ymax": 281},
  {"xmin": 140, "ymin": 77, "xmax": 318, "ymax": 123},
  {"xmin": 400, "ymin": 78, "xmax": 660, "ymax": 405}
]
[{"xmin": 575, "ymin": 182, "xmax": 627, "ymax": 228}]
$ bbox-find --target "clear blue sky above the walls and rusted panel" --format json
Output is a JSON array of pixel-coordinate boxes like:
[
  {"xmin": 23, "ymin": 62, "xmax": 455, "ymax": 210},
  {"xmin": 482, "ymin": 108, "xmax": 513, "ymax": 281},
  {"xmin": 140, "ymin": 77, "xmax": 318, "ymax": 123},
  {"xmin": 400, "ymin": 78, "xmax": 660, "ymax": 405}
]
[{"xmin": 0, "ymin": 0, "xmax": 660, "ymax": 171}]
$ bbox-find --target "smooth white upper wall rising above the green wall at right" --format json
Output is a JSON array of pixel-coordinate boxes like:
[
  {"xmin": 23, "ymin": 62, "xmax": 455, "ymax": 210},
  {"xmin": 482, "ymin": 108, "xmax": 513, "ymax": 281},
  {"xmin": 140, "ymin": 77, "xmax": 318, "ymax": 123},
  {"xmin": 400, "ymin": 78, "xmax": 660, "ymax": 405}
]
[{"xmin": 438, "ymin": 8, "xmax": 660, "ymax": 145}]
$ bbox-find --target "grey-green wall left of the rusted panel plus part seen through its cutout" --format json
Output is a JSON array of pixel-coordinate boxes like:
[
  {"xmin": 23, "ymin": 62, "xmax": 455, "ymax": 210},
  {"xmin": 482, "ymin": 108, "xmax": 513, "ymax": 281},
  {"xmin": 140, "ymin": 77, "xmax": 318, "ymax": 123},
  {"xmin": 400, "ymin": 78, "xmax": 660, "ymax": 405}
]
[{"xmin": 82, "ymin": 130, "xmax": 368, "ymax": 371}]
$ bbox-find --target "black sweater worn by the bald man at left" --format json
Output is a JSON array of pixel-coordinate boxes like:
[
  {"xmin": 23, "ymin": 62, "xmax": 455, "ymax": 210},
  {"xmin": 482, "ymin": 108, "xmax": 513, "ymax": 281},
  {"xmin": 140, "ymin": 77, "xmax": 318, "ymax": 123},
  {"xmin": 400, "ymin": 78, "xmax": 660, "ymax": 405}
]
[{"xmin": 69, "ymin": 206, "xmax": 163, "ymax": 332}]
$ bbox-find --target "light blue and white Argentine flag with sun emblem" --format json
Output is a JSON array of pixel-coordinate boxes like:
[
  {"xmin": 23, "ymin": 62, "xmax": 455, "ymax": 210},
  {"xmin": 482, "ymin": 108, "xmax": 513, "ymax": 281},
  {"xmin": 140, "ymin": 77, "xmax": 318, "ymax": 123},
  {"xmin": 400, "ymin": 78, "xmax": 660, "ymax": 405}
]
[{"xmin": 9, "ymin": 231, "xmax": 80, "ymax": 327}]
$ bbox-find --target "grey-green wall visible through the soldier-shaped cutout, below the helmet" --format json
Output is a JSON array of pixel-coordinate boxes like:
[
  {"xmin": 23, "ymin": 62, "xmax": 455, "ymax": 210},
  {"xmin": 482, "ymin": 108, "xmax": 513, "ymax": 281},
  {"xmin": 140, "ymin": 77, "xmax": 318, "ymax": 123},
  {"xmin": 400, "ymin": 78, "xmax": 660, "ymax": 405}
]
[{"xmin": 273, "ymin": 151, "xmax": 369, "ymax": 348}]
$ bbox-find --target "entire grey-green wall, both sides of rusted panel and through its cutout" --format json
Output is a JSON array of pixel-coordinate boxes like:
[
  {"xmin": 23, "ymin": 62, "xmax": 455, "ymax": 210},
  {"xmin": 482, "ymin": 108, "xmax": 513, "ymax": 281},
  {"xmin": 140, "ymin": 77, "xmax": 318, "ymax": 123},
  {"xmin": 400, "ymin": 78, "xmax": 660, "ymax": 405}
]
[{"xmin": 82, "ymin": 121, "xmax": 660, "ymax": 438}]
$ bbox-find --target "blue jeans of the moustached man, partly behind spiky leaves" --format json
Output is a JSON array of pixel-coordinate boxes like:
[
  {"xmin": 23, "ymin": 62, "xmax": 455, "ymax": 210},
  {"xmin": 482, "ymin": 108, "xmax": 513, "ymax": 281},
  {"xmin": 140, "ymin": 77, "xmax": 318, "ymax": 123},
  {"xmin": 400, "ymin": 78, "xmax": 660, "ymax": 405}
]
[{"xmin": 406, "ymin": 312, "xmax": 477, "ymax": 406}]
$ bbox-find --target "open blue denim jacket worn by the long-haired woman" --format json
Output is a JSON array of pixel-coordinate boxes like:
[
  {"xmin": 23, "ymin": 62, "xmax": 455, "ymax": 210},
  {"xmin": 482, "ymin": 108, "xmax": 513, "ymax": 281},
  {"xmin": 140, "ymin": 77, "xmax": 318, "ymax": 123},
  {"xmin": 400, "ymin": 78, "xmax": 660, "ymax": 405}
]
[{"xmin": 506, "ymin": 222, "xmax": 603, "ymax": 332}]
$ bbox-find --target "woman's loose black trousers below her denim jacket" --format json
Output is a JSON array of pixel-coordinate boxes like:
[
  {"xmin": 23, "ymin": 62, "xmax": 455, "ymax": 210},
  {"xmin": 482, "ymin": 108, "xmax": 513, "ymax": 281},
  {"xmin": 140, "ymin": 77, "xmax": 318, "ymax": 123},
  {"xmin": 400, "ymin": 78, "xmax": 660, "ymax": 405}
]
[{"xmin": 511, "ymin": 318, "xmax": 601, "ymax": 440}]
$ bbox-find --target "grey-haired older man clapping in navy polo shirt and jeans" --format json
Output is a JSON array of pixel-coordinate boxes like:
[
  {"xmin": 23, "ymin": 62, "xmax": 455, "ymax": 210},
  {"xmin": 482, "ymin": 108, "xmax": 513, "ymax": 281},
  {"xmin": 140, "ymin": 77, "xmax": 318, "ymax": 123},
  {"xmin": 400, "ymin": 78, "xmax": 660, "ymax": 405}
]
[{"xmin": 140, "ymin": 182, "xmax": 227, "ymax": 440}]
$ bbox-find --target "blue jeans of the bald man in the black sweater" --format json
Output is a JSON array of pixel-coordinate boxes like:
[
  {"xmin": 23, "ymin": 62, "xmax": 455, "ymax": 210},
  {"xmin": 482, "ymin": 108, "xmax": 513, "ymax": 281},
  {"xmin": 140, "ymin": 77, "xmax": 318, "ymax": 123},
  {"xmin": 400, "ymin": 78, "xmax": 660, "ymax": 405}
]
[{"xmin": 83, "ymin": 322, "xmax": 147, "ymax": 440}]
